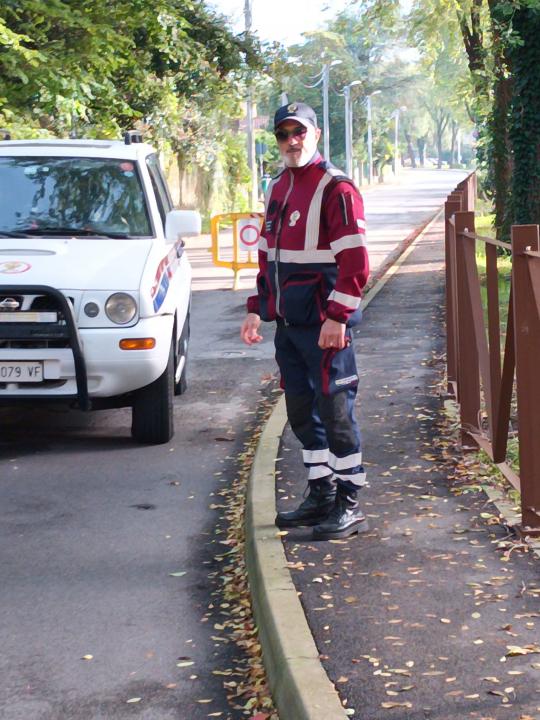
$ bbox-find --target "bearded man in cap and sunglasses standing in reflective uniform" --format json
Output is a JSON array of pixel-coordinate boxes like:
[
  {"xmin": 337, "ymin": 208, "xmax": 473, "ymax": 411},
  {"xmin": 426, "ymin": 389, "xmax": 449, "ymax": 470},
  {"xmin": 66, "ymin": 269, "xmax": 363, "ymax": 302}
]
[{"xmin": 241, "ymin": 102, "xmax": 369, "ymax": 540}]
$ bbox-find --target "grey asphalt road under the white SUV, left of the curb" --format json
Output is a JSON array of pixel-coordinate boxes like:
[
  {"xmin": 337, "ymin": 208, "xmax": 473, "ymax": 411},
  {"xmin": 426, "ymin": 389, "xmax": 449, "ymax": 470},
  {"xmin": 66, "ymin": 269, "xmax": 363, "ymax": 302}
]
[{"xmin": 0, "ymin": 166, "xmax": 463, "ymax": 720}]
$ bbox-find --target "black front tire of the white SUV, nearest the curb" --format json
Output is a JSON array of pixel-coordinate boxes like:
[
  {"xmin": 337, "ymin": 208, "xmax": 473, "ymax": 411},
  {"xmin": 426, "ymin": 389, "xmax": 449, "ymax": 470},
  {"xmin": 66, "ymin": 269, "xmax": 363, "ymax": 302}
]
[{"xmin": 131, "ymin": 343, "xmax": 174, "ymax": 445}]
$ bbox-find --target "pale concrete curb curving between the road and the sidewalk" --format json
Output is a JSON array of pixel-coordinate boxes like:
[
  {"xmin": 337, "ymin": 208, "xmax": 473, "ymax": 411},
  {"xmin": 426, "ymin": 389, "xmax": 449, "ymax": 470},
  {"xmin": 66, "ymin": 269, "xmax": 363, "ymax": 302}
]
[{"xmin": 246, "ymin": 209, "xmax": 442, "ymax": 720}]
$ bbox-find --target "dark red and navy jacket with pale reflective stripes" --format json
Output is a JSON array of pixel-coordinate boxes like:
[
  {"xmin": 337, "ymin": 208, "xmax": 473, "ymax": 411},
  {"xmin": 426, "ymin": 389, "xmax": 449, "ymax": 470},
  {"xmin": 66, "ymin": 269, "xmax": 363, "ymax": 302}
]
[{"xmin": 247, "ymin": 153, "xmax": 369, "ymax": 325}]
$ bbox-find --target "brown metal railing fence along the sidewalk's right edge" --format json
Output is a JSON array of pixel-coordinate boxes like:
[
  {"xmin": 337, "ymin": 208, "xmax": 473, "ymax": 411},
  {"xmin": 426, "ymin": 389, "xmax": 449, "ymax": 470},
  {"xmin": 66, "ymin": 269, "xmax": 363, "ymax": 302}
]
[{"xmin": 445, "ymin": 173, "xmax": 540, "ymax": 534}]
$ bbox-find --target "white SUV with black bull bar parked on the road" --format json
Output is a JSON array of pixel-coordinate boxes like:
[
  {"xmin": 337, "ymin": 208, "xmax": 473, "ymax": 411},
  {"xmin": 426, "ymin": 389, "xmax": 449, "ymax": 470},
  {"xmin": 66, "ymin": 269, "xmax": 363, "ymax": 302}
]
[{"xmin": 0, "ymin": 132, "xmax": 200, "ymax": 443}]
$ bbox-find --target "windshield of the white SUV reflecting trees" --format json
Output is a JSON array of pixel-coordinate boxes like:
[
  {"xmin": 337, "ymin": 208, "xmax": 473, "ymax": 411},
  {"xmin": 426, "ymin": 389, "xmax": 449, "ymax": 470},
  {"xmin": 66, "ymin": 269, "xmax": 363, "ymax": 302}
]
[{"xmin": 0, "ymin": 156, "xmax": 152, "ymax": 237}]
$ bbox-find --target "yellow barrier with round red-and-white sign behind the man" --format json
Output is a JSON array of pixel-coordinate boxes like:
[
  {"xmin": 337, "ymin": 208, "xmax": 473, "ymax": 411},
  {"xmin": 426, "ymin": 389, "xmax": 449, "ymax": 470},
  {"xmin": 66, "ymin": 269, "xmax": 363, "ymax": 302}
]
[{"xmin": 210, "ymin": 212, "xmax": 264, "ymax": 290}]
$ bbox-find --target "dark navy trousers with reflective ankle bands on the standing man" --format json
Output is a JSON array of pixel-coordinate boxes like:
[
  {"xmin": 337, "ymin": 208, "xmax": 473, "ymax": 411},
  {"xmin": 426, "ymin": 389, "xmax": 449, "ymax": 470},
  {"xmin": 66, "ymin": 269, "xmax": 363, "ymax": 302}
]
[{"xmin": 275, "ymin": 320, "xmax": 366, "ymax": 489}]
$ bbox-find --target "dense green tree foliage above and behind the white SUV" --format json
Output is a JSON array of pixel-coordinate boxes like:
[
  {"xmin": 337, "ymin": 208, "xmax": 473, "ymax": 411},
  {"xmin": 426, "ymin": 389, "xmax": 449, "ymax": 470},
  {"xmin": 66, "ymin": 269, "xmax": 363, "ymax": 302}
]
[{"xmin": 0, "ymin": 0, "xmax": 263, "ymax": 166}]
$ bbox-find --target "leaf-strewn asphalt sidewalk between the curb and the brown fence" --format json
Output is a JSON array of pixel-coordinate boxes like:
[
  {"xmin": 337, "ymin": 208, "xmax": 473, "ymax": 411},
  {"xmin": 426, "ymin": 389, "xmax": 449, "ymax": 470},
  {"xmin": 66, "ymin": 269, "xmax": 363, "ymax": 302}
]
[{"xmin": 277, "ymin": 217, "xmax": 540, "ymax": 720}]
